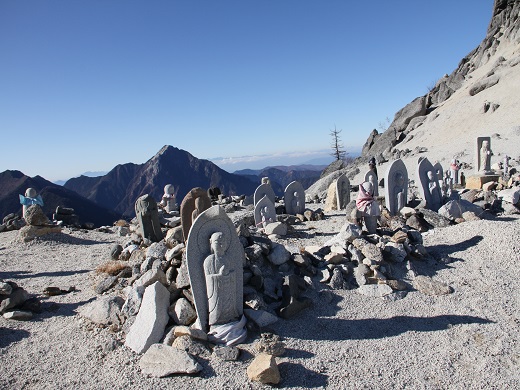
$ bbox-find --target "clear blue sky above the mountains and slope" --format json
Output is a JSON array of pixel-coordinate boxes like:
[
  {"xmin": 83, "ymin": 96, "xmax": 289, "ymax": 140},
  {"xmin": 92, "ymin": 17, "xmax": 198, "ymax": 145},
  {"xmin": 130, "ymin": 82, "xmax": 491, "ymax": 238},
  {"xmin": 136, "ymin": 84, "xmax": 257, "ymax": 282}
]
[{"xmin": 0, "ymin": 0, "xmax": 493, "ymax": 181}]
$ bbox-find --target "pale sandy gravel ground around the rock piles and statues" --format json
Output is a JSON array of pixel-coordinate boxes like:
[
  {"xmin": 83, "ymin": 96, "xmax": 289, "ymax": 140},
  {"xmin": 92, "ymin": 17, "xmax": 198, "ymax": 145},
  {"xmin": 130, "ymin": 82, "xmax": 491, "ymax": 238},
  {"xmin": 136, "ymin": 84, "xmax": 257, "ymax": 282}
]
[{"xmin": 0, "ymin": 213, "xmax": 520, "ymax": 389}]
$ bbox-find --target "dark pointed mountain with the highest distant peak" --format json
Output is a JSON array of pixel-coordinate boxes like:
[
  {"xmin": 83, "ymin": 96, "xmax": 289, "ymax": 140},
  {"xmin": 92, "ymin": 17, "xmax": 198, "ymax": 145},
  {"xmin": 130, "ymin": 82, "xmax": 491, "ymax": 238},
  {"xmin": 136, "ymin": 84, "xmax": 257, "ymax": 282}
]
[{"xmin": 64, "ymin": 145, "xmax": 259, "ymax": 216}]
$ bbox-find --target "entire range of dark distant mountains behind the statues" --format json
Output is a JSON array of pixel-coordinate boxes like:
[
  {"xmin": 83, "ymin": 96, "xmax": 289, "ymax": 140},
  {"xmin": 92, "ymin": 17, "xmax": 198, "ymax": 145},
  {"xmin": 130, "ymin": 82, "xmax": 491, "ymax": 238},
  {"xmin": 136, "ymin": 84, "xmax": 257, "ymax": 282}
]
[{"xmin": 0, "ymin": 145, "xmax": 332, "ymax": 225}]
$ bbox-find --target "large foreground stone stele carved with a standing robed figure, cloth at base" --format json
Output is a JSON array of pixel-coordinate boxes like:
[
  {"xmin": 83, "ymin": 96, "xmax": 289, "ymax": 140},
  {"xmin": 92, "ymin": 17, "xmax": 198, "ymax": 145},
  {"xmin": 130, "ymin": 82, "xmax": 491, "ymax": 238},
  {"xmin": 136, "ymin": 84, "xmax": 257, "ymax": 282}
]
[{"xmin": 186, "ymin": 206, "xmax": 247, "ymax": 345}]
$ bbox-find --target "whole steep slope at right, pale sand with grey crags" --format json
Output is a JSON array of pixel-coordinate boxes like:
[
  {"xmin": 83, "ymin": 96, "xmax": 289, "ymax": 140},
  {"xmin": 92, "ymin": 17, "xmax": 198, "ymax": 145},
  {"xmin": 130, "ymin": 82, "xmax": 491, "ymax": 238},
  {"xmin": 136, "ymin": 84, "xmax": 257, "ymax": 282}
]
[{"xmin": 338, "ymin": 0, "xmax": 520, "ymax": 191}]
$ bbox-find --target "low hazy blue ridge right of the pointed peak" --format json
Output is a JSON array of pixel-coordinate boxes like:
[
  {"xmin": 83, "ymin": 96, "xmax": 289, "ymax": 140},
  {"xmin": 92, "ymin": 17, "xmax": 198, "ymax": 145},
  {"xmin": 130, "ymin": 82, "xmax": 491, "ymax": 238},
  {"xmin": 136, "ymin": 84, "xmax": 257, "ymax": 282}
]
[{"xmin": 234, "ymin": 165, "xmax": 324, "ymax": 196}]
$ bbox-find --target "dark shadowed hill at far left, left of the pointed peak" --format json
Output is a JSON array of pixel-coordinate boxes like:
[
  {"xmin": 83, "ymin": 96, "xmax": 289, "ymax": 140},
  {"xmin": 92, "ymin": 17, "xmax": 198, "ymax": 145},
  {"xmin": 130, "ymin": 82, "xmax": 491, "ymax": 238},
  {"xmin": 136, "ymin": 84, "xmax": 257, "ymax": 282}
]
[{"xmin": 0, "ymin": 171, "xmax": 121, "ymax": 226}]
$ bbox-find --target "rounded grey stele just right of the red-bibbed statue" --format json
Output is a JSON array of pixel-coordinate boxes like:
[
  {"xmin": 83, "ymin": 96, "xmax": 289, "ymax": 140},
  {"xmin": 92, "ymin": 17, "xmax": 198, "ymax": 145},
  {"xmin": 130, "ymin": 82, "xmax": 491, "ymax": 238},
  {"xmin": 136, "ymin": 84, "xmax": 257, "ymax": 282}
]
[{"xmin": 385, "ymin": 159, "xmax": 408, "ymax": 215}]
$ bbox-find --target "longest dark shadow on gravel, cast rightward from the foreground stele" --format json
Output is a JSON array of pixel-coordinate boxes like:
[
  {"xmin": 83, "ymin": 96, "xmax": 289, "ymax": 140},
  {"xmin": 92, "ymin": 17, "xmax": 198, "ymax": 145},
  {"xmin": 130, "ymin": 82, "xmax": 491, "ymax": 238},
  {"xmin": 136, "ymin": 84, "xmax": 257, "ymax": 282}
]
[{"xmin": 278, "ymin": 315, "xmax": 494, "ymax": 341}]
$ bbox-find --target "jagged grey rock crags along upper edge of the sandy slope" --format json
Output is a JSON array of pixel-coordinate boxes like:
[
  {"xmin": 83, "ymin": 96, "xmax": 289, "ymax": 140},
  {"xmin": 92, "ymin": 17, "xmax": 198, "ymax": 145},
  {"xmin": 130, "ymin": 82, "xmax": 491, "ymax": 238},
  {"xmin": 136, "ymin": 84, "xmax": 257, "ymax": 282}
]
[{"xmin": 362, "ymin": 0, "xmax": 520, "ymax": 161}]
